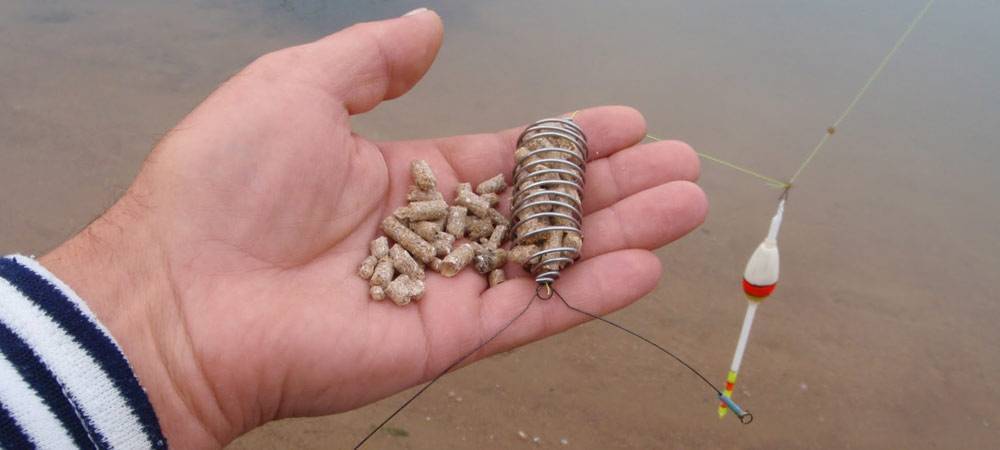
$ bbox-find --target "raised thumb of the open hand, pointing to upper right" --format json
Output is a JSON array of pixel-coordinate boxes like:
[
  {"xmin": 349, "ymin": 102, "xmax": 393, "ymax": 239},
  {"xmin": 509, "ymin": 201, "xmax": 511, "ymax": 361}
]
[{"xmin": 254, "ymin": 10, "xmax": 444, "ymax": 114}]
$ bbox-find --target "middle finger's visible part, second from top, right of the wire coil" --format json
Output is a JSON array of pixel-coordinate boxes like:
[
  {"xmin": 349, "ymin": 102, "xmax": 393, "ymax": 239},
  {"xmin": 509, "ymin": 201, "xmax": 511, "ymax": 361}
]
[{"xmin": 583, "ymin": 141, "xmax": 701, "ymax": 214}]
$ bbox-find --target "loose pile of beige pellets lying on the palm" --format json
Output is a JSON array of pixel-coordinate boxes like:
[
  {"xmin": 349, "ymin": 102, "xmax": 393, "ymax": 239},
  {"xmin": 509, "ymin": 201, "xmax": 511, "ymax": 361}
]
[{"xmin": 358, "ymin": 160, "xmax": 523, "ymax": 306}]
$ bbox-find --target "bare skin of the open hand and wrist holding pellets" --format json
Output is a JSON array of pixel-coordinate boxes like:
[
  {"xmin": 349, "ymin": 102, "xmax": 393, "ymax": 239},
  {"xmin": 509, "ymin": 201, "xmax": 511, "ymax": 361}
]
[{"xmin": 41, "ymin": 11, "xmax": 707, "ymax": 448}]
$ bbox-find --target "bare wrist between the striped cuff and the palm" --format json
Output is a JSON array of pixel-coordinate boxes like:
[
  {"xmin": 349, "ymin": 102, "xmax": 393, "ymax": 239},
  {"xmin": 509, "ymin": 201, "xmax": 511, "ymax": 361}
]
[{"xmin": 39, "ymin": 196, "xmax": 225, "ymax": 448}]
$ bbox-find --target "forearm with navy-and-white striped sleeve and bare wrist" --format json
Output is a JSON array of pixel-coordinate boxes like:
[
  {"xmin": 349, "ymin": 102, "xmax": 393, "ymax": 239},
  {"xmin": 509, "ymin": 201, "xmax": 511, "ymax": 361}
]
[{"xmin": 0, "ymin": 199, "xmax": 227, "ymax": 449}]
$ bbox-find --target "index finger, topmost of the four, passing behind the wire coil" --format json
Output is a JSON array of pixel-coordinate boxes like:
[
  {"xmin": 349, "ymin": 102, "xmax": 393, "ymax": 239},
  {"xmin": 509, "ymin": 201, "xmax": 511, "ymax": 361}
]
[{"xmin": 435, "ymin": 106, "xmax": 646, "ymax": 183}]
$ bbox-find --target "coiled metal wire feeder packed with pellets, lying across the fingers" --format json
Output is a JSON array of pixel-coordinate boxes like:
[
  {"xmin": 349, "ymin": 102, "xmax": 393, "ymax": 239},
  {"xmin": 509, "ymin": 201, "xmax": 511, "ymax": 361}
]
[{"xmin": 511, "ymin": 118, "xmax": 588, "ymax": 286}]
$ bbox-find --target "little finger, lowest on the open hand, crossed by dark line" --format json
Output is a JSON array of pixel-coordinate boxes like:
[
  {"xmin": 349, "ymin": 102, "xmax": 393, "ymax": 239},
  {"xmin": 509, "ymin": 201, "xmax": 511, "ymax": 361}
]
[{"xmin": 476, "ymin": 249, "xmax": 661, "ymax": 359}]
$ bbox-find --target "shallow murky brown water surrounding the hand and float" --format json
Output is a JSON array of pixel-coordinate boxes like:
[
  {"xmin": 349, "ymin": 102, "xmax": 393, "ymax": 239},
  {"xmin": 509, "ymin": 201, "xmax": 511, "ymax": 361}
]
[{"xmin": 0, "ymin": 0, "xmax": 1000, "ymax": 449}]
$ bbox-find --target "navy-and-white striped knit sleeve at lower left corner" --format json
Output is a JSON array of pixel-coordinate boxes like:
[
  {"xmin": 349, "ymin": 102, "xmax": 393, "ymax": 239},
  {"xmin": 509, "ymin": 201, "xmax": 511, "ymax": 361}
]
[{"xmin": 0, "ymin": 256, "xmax": 167, "ymax": 449}]
